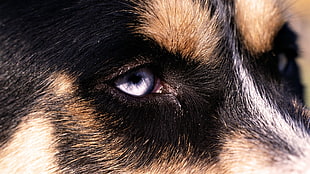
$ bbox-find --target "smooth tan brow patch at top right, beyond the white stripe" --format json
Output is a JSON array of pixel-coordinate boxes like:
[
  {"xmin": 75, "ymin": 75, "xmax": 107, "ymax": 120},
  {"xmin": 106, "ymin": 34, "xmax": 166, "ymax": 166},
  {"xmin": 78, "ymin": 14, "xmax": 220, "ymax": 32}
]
[{"xmin": 236, "ymin": 0, "xmax": 287, "ymax": 54}]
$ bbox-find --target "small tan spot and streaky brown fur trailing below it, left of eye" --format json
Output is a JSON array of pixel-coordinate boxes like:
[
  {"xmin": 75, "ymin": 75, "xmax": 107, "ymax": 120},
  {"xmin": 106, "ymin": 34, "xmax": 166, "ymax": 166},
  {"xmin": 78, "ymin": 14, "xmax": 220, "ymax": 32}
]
[{"xmin": 50, "ymin": 72, "xmax": 126, "ymax": 173}]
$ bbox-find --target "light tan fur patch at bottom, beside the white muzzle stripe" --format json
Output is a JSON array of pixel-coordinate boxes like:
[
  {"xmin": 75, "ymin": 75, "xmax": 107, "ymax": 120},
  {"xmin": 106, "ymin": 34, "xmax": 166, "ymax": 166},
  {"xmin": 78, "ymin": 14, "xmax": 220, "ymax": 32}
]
[{"xmin": 218, "ymin": 133, "xmax": 280, "ymax": 174}]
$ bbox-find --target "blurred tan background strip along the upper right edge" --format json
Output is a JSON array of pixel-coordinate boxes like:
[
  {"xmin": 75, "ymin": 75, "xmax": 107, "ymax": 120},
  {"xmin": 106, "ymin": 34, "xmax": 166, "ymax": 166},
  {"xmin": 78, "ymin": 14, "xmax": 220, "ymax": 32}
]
[{"xmin": 290, "ymin": 0, "xmax": 310, "ymax": 107}]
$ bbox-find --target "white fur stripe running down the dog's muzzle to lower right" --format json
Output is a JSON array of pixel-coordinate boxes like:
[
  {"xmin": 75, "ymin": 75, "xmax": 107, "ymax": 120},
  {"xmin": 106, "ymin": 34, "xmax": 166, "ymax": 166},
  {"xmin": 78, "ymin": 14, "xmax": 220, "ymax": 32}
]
[{"xmin": 234, "ymin": 54, "xmax": 310, "ymax": 173}]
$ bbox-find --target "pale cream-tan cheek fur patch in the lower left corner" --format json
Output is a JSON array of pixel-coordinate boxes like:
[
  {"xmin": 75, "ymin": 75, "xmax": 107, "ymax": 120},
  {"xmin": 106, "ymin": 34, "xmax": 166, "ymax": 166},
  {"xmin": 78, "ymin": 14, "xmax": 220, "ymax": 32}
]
[{"xmin": 0, "ymin": 112, "xmax": 57, "ymax": 174}]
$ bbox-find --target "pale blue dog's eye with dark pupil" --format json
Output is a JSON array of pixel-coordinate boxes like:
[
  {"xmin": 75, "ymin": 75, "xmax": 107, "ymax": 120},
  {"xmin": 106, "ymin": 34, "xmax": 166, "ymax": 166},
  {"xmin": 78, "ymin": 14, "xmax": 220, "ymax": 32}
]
[{"xmin": 115, "ymin": 68, "xmax": 156, "ymax": 96}]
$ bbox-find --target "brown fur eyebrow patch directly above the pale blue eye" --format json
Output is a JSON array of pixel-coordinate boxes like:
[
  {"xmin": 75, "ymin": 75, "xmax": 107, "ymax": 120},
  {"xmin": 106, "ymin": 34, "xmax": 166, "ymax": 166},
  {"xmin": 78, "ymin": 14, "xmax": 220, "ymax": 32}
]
[{"xmin": 135, "ymin": 0, "xmax": 219, "ymax": 61}]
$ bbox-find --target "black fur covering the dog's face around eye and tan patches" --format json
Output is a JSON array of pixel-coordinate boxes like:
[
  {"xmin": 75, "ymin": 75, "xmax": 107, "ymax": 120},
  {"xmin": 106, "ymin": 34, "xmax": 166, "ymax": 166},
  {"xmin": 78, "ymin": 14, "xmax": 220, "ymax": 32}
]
[{"xmin": 0, "ymin": 0, "xmax": 309, "ymax": 173}]
